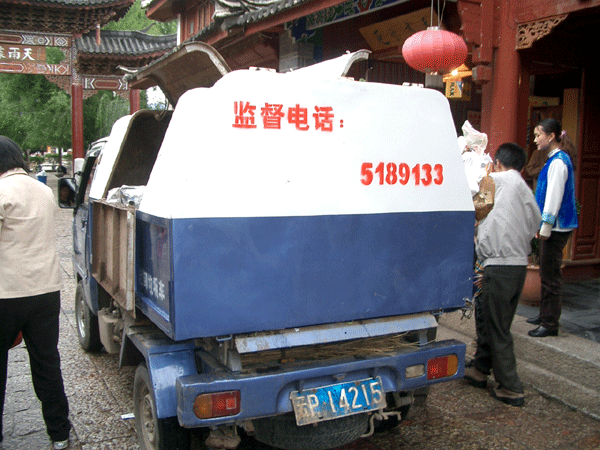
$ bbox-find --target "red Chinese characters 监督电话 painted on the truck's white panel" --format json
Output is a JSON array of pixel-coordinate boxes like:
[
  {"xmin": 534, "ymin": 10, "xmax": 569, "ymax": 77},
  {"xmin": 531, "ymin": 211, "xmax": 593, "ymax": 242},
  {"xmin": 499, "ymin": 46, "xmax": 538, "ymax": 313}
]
[{"xmin": 232, "ymin": 101, "xmax": 344, "ymax": 132}]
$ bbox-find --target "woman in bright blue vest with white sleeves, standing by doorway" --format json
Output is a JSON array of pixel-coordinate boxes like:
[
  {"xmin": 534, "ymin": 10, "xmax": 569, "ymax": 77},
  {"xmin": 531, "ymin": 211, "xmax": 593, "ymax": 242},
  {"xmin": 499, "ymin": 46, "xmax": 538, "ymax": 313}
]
[{"xmin": 527, "ymin": 119, "xmax": 577, "ymax": 337}]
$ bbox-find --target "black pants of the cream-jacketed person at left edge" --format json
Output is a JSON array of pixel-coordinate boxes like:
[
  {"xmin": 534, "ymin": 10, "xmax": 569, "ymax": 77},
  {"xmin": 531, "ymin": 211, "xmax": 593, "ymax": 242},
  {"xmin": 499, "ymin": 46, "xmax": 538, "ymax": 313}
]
[{"xmin": 0, "ymin": 291, "xmax": 71, "ymax": 441}]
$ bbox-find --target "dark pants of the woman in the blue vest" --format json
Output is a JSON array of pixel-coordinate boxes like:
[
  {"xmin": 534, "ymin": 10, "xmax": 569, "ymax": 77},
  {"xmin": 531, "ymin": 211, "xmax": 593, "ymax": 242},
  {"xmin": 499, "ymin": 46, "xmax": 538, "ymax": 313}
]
[{"xmin": 540, "ymin": 231, "xmax": 571, "ymax": 331}]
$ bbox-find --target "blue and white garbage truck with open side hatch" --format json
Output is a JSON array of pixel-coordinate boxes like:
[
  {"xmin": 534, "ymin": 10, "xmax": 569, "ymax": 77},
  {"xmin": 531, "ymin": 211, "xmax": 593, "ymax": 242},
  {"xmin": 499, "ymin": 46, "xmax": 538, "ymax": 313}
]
[{"xmin": 59, "ymin": 43, "xmax": 474, "ymax": 450}]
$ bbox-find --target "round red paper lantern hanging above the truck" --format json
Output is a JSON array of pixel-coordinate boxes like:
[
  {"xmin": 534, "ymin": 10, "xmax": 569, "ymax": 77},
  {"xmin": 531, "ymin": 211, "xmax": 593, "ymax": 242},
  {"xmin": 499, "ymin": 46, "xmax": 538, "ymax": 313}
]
[{"xmin": 402, "ymin": 27, "xmax": 467, "ymax": 73}]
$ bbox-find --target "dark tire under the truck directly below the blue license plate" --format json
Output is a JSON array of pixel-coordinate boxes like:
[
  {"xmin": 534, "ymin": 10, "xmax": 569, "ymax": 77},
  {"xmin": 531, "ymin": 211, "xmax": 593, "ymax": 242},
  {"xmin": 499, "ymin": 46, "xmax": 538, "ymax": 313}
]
[{"xmin": 252, "ymin": 413, "xmax": 369, "ymax": 450}]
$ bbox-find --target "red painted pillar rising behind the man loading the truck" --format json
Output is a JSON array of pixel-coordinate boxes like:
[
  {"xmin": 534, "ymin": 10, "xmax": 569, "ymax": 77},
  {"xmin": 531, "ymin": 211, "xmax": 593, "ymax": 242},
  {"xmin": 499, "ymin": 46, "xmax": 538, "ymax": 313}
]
[{"xmin": 481, "ymin": 1, "xmax": 520, "ymax": 154}]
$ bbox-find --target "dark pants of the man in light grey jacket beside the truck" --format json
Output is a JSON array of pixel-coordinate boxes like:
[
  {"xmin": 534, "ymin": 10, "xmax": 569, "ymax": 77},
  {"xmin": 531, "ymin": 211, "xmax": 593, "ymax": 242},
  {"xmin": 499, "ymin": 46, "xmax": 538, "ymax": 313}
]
[{"xmin": 473, "ymin": 266, "xmax": 527, "ymax": 393}]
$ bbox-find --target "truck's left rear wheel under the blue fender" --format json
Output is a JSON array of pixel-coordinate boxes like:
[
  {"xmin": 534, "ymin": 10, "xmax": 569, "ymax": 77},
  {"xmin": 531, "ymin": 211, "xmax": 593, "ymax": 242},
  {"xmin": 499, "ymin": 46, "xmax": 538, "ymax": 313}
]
[{"xmin": 133, "ymin": 363, "xmax": 190, "ymax": 450}]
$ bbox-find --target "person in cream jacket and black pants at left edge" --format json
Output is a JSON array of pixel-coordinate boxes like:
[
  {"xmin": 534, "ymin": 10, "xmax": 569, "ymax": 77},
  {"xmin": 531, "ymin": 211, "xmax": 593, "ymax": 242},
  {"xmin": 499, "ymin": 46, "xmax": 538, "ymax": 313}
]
[{"xmin": 0, "ymin": 136, "xmax": 71, "ymax": 449}]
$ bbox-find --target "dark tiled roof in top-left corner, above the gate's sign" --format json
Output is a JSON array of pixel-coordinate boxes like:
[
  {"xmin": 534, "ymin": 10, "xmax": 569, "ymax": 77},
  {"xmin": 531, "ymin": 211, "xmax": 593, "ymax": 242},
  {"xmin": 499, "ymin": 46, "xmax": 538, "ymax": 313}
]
[{"xmin": 0, "ymin": 0, "xmax": 135, "ymax": 34}]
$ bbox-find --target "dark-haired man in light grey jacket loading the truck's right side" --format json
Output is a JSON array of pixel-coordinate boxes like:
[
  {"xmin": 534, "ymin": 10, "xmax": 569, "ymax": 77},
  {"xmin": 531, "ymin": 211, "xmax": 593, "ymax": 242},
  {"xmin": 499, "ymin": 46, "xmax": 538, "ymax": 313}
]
[{"xmin": 465, "ymin": 143, "xmax": 542, "ymax": 406}]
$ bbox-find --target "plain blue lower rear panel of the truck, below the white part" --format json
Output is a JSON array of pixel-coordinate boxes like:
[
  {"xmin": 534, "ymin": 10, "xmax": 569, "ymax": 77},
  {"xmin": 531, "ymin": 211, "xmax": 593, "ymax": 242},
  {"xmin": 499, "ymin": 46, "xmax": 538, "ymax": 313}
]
[{"xmin": 155, "ymin": 211, "xmax": 474, "ymax": 340}]
